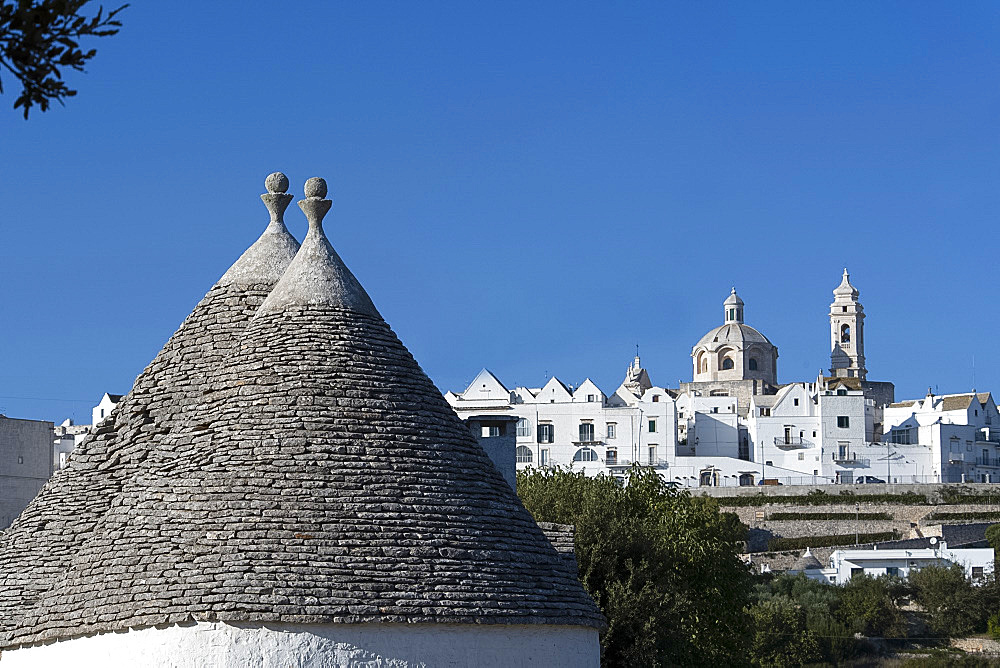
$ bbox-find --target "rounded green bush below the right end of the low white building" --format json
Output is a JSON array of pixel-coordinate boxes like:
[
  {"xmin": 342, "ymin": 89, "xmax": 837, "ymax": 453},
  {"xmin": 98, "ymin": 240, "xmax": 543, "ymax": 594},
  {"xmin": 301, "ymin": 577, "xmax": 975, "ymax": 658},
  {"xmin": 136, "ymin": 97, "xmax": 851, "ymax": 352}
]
[{"xmin": 909, "ymin": 564, "xmax": 980, "ymax": 637}]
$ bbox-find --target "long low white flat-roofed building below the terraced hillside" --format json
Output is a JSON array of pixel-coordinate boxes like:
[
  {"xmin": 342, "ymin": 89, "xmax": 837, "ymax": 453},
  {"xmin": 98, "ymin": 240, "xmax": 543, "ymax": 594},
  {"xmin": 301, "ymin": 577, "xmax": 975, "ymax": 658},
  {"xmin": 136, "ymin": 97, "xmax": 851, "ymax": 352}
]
[{"xmin": 790, "ymin": 539, "xmax": 994, "ymax": 584}]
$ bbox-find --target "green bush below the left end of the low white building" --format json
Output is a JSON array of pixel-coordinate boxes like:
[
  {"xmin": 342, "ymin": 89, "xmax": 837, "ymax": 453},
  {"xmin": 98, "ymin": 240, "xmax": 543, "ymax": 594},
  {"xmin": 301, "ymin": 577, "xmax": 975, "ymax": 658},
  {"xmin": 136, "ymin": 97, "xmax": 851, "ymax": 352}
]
[{"xmin": 837, "ymin": 575, "xmax": 906, "ymax": 638}]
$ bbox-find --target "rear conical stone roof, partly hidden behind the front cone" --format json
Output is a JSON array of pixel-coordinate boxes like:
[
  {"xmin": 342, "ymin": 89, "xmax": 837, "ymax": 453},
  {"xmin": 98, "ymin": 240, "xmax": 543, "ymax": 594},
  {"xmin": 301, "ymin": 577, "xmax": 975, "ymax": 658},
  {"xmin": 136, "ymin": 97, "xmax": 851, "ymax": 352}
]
[{"xmin": 0, "ymin": 173, "xmax": 299, "ymax": 645}]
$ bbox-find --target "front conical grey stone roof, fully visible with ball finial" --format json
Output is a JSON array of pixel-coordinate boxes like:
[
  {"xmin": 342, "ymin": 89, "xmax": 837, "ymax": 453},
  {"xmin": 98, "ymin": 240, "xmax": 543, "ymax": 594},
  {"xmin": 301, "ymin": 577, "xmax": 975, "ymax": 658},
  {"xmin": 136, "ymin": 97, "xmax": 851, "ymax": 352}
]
[{"xmin": 1, "ymin": 180, "xmax": 604, "ymax": 644}]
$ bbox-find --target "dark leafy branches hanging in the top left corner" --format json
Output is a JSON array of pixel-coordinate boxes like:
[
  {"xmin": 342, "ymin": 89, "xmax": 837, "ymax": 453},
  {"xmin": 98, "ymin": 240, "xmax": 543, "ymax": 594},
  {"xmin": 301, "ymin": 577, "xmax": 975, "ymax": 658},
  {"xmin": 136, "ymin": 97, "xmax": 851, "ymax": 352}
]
[{"xmin": 0, "ymin": 0, "xmax": 128, "ymax": 118}]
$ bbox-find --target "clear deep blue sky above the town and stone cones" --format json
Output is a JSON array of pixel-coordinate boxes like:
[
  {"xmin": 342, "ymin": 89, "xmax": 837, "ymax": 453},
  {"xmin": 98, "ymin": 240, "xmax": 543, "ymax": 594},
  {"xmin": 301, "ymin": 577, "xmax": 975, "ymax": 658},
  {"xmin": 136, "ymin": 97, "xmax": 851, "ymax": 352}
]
[{"xmin": 0, "ymin": 2, "xmax": 1000, "ymax": 422}]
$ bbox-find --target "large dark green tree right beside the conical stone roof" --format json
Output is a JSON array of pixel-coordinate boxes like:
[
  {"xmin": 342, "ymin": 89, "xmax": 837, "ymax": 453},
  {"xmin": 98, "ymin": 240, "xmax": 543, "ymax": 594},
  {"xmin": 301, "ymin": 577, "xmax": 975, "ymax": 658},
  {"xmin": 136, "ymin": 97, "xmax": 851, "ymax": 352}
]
[{"xmin": 517, "ymin": 467, "xmax": 752, "ymax": 666}]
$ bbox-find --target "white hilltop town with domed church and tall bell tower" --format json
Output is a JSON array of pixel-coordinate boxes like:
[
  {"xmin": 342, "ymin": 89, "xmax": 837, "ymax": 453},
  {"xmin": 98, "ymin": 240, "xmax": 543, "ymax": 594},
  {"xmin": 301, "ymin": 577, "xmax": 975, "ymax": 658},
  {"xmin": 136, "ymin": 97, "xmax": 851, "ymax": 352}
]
[{"xmin": 446, "ymin": 269, "xmax": 1000, "ymax": 486}]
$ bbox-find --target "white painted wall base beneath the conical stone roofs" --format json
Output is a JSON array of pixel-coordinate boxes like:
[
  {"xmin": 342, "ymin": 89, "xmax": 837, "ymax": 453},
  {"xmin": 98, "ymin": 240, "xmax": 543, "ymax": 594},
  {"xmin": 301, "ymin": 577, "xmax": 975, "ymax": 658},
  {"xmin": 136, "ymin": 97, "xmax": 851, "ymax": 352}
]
[{"xmin": 0, "ymin": 622, "xmax": 600, "ymax": 668}]
